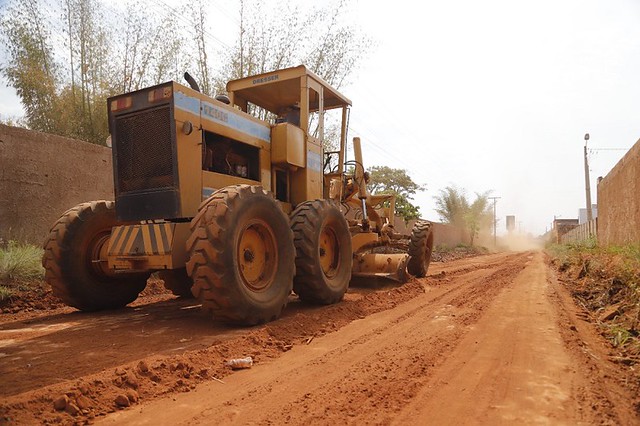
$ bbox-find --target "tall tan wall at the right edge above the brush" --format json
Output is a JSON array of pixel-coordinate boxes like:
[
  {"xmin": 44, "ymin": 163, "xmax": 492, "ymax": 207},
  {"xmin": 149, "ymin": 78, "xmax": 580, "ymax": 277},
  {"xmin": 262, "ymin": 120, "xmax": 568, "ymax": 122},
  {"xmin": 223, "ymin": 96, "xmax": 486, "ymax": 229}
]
[{"xmin": 598, "ymin": 140, "xmax": 640, "ymax": 245}]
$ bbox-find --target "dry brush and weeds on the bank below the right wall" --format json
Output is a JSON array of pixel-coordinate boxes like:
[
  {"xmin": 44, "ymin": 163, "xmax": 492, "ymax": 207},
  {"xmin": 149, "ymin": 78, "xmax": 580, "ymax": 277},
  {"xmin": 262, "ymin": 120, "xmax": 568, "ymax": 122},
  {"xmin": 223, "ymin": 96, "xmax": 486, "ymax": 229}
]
[{"xmin": 548, "ymin": 241, "xmax": 640, "ymax": 365}]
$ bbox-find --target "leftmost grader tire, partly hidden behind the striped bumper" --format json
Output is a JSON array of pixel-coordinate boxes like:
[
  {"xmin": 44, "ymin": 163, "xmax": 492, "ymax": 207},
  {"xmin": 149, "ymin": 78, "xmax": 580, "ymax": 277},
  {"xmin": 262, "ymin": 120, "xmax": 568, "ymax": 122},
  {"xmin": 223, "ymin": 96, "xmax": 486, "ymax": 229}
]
[{"xmin": 42, "ymin": 200, "xmax": 150, "ymax": 311}]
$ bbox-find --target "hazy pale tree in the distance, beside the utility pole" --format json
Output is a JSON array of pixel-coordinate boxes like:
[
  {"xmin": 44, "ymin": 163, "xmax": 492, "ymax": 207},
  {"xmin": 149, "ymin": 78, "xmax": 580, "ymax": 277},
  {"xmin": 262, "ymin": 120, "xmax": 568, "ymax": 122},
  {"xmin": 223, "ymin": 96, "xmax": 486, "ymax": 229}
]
[{"xmin": 434, "ymin": 185, "xmax": 492, "ymax": 245}]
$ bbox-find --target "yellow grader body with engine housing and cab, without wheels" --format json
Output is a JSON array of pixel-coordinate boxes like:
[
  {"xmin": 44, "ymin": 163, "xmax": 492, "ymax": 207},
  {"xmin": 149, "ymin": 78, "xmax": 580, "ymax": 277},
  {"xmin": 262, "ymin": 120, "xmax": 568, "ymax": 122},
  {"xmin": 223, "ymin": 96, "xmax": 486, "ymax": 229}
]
[{"xmin": 107, "ymin": 66, "xmax": 351, "ymax": 271}]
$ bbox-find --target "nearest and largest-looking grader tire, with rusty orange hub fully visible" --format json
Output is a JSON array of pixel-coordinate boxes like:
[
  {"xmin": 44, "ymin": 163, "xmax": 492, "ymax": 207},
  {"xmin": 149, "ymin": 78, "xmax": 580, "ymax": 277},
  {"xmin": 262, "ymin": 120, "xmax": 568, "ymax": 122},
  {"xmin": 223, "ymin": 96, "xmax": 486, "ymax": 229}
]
[{"xmin": 187, "ymin": 185, "xmax": 295, "ymax": 325}]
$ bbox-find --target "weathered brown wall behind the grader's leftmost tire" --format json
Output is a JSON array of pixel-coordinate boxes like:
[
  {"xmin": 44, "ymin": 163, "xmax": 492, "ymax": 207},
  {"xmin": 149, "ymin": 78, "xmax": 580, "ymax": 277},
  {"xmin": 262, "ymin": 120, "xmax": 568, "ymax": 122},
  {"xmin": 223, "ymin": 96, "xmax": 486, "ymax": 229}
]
[{"xmin": 0, "ymin": 125, "xmax": 114, "ymax": 244}]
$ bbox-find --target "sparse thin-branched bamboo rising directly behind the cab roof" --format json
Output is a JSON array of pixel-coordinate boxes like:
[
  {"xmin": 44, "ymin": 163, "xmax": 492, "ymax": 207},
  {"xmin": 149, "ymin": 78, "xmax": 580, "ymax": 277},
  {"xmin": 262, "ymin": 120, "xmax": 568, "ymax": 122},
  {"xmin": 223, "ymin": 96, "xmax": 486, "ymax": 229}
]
[{"xmin": 216, "ymin": 0, "xmax": 371, "ymax": 96}]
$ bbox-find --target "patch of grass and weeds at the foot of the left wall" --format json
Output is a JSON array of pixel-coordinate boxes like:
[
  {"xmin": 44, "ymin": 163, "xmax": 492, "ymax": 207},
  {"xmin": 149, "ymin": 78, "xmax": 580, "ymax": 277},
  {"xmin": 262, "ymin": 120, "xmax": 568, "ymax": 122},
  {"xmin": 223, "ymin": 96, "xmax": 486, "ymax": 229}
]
[{"xmin": 0, "ymin": 240, "xmax": 44, "ymax": 303}]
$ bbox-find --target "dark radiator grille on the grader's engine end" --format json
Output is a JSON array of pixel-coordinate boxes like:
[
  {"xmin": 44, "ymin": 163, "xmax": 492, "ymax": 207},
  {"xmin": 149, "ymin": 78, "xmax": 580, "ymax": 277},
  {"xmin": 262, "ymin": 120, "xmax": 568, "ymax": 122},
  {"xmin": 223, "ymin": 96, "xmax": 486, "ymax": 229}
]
[{"xmin": 115, "ymin": 106, "xmax": 175, "ymax": 192}]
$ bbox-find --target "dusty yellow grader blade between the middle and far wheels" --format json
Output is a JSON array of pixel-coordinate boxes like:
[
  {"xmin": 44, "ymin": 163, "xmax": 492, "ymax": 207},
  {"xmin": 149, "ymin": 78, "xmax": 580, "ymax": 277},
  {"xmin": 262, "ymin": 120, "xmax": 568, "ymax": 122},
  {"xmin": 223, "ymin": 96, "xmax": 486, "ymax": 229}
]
[{"xmin": 351, "ymin": 253, "xmax": 409, "ymax": 283}]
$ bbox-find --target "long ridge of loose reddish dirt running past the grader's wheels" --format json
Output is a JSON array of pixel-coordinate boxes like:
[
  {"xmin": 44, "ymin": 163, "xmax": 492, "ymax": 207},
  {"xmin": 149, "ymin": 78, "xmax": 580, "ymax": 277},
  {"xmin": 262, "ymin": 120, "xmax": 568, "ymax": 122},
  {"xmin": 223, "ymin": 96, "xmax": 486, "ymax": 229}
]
[{"xmin": 0, "ymin": 281, "xmax": 424, "ymax": 424}]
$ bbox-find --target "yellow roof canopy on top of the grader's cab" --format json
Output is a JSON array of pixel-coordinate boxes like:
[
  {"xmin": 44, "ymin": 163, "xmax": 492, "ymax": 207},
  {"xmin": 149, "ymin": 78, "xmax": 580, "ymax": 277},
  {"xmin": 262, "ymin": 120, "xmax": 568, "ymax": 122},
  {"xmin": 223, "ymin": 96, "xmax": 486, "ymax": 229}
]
[{"xmin": 227, "ymin": 65, "xmax": 351, "ymax": 114}]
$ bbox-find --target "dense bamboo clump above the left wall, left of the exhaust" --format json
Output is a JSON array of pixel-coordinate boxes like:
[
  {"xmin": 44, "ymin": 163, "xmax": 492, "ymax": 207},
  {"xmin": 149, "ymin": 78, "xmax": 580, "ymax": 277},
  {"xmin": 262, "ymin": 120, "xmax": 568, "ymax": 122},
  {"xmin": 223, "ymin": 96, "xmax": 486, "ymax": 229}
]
[{"xmin": 0, "ymin": 0, "xmax": 198, "ymax": 145}]
